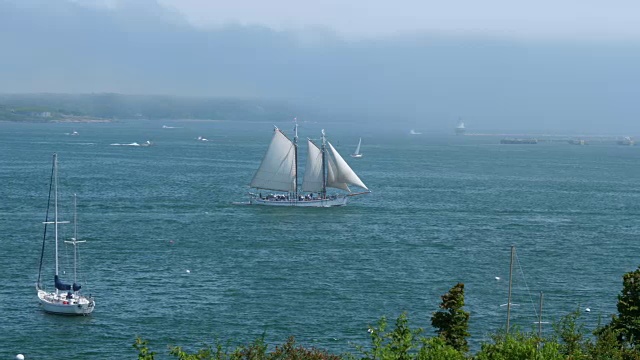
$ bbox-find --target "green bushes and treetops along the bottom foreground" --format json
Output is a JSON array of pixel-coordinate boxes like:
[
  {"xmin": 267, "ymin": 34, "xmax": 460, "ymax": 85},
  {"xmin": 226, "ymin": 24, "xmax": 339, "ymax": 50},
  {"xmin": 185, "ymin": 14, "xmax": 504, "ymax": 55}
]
[{"xmin": 133, "ymin": 267, "xmax": 640, "ymax": 360}]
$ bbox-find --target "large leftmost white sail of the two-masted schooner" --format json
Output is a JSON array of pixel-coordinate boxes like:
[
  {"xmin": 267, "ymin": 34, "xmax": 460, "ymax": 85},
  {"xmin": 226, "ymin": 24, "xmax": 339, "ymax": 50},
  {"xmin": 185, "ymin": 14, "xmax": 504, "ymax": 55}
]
[{"xmin": 251, "ymin": 128, "xmax": 296, "ymax": 192}]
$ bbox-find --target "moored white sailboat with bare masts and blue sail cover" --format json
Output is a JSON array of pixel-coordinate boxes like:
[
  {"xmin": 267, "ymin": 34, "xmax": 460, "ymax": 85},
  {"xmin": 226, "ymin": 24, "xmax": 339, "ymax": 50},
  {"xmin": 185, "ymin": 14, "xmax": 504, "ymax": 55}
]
[{"xmin": 36, "ymin": 154, "xmax": 96, "ymax": 315}]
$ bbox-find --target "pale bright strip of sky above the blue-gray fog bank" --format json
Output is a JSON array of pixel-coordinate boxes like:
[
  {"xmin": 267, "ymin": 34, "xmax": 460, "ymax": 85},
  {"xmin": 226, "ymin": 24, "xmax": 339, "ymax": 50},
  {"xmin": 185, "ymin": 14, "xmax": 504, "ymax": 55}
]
[{"xmin": 156, "ymin": 0, "xmax": 640, "ymax": 40}]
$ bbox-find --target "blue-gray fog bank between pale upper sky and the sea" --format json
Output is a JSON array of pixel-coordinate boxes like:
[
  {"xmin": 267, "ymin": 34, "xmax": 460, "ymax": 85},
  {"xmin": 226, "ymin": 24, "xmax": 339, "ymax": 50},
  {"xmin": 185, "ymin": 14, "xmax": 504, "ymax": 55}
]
[{"xmin": 0, "ymin": 0, "xmax": 640, "ymax": 133}]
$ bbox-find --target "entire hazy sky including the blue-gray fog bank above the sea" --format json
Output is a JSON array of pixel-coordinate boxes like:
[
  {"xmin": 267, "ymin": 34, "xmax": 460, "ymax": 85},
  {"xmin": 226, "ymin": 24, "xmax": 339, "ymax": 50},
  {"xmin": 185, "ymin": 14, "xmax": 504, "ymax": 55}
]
[{"xmin": 0, "ymin": 0, "xmax": 640, "ymax": 134}]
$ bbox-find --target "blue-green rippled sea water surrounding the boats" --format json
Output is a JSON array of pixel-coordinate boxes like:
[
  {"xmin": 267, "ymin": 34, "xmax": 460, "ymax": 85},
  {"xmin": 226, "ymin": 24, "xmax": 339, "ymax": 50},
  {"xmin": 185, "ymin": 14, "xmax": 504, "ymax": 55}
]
[{"xmin": 0, "ymin": 121, "xmax": 640, "ymax": 359}]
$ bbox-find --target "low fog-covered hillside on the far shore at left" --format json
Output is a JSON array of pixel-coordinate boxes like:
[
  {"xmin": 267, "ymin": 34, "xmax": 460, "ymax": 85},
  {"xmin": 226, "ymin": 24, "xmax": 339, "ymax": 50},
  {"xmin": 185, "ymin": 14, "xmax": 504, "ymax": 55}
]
[{"xmin": 0, "ymin": 93, "xmax": 309, "ymax": 122}]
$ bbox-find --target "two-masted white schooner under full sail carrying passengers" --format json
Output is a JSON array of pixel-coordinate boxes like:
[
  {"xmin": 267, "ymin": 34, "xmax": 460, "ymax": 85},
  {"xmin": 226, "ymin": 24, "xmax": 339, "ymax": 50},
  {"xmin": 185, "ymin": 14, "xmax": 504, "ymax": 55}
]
[{"xmin": 249, "ymin": 124, "xmax": 371, "ymax": 207}]
